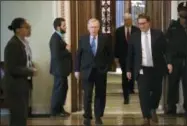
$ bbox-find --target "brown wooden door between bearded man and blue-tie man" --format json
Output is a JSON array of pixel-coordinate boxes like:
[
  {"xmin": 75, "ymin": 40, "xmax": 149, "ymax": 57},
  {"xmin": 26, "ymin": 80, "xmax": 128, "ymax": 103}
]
[{"xmin": 70, "ymin": 0, "xmax": 96, "ymax": 112}]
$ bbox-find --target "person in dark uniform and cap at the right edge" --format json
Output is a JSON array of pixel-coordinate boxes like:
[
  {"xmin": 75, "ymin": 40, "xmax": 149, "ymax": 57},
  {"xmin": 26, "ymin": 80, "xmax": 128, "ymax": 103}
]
[{"xmin": 166, "ymin": 2, "xmax": 187, "ymax": 115}]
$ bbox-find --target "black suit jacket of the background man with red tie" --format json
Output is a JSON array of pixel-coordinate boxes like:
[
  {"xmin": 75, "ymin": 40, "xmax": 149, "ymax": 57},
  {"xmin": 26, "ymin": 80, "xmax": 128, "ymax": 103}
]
[{"xmin": 115, "ymin": 26, "xmax": 139, "ymax": 67}]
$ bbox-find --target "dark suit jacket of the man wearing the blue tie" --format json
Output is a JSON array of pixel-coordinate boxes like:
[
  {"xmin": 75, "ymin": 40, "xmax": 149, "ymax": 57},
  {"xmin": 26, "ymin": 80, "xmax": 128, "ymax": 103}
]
[{"xmin": 75, "ymin": 34, "xmax": 113, "ymax": 79}]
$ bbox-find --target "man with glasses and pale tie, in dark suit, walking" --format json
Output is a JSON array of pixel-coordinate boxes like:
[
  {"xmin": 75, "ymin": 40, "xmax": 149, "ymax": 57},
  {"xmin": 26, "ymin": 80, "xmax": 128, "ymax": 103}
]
[{"xmin": 127, "ymin": 14, "xmax": 172, "ymax": 125}]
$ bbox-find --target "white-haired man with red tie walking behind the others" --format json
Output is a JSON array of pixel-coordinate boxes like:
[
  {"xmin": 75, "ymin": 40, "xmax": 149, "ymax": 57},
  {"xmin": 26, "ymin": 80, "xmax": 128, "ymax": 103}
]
[{"xmin": 115, "ymin": 13, "xmax": 139, "ymax": 104}]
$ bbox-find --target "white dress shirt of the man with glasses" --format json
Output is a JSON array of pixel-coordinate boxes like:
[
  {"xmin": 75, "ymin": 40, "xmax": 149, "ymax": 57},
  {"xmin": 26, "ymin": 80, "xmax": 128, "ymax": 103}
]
[{"xmin": 141, "ymin": 29, "xmax": 153, "ymax": 67}]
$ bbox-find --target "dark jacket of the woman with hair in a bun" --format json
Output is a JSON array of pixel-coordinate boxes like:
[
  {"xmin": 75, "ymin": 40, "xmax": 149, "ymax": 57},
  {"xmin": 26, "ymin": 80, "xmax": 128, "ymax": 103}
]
[{"xmin": 4, "ymin": 36, "xmax": 33, "ymax": 93}]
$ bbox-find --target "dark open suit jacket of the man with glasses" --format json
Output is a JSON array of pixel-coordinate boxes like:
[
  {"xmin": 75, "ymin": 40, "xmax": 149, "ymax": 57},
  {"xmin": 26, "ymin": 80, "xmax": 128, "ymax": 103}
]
[{"xmin": 127, "ymin": 29, "xmax": 170, "ymax": 78}]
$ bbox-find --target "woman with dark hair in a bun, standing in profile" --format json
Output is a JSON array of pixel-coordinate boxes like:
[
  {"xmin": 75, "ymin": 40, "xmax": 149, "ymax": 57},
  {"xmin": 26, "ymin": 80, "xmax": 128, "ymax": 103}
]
[{"xmin": 4, "ymin": 18, "xmax": 36, "ymax": 126}]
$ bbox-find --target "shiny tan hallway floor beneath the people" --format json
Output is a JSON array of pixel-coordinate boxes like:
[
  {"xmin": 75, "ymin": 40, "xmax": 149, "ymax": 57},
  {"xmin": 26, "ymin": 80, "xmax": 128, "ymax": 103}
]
[{"xmin": 1, "ymin": 94, "xmax": 185, "ymax": 126}]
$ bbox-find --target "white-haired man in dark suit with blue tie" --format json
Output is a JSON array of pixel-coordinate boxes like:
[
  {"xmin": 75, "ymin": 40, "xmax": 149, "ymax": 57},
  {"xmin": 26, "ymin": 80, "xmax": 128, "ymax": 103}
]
[{"xmin": 75, "ymin": 18, "xmax": 113, "ymax": 125}]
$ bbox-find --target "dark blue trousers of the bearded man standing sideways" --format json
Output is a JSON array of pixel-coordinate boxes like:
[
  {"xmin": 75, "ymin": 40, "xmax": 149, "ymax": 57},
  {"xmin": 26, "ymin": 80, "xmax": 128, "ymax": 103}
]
[{"xmin": 51, "ymin": 76, "xmax": 68, "ymax": 115}]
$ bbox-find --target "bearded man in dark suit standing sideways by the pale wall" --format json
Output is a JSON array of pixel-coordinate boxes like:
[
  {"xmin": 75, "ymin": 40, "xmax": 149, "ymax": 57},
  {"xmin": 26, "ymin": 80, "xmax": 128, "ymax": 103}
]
[{"xmin": 49, "ymin": 18, "xmax": 72, "ymax": 117}]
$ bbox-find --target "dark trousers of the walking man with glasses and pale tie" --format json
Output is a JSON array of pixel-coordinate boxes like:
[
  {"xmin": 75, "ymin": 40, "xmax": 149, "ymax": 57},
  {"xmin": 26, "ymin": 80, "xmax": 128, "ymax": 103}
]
[{"xmin": 137, "ymin": 67, "xmax": 163, "ymax": 118}]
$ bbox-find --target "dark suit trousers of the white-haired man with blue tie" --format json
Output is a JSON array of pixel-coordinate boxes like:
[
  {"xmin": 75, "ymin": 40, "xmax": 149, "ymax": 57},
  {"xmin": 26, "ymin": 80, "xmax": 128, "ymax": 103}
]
[{"xmin": 82, "ymin": 69, "xmax": 106, "ymax": 119}]
